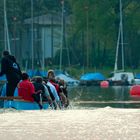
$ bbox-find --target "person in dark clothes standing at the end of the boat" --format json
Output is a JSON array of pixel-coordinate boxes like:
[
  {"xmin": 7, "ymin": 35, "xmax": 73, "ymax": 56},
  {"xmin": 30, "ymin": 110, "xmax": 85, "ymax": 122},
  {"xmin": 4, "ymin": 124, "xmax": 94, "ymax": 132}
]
[{"xmin": 0, "ymin": 51, "xmax": 22, "ymax": 96}]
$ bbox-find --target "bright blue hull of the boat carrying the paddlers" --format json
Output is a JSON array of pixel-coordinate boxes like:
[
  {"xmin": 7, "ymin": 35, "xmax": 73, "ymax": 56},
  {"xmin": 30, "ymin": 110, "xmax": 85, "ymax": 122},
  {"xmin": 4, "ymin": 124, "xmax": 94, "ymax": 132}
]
[{"xmin": 0, "ymin": 97, "xmax": 49, "ymax": 110}]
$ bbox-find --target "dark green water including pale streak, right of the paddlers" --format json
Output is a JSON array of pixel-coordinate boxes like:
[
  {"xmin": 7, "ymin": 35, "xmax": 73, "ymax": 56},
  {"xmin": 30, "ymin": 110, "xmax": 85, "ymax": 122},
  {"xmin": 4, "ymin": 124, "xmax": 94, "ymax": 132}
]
[{"xmin": 69, "ymin": 86, "xmax": 140, "ymax": 108}]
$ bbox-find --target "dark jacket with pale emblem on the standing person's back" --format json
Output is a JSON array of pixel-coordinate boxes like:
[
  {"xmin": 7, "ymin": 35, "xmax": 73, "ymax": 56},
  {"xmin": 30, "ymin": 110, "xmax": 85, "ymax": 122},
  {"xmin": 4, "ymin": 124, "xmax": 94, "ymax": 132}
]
[{"xmin": 0, "ymin": 55, "xmax": 21, "ymax": 83}]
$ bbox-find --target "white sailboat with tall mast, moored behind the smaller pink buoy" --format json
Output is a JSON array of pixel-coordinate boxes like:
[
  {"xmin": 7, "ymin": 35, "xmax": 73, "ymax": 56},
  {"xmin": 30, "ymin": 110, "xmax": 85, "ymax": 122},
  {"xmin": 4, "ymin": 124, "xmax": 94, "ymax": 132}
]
[{"xmin": 108, "ymin": 0, "xmax": 135, "ymax": 85}]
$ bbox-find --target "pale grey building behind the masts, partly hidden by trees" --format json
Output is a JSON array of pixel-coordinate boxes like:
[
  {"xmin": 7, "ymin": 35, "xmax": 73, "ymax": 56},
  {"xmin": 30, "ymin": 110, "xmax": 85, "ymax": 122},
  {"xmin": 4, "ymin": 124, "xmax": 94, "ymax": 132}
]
[{"xmin": 18, "ymin": 14, "xmax": 70, "ymax": 67}]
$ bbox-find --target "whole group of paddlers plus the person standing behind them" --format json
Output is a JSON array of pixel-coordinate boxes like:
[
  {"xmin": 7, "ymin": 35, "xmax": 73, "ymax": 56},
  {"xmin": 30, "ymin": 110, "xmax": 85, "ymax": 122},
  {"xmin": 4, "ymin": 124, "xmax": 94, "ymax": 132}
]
[{"xmin": 0, "ymin": 51, "xmax": 69, "ymax": 109}]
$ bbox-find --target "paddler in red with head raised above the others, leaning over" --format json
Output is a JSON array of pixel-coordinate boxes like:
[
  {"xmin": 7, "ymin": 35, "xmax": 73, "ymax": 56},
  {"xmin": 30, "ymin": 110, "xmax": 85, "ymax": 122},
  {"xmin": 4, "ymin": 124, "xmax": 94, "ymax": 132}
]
[{"xmin": 47, "ymin": 70, "xmax": 67, "ymax": 106}]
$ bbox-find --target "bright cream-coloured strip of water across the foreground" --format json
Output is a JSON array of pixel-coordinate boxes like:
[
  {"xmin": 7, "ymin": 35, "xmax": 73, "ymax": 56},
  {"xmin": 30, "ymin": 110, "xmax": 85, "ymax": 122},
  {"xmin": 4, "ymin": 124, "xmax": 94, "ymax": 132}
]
[{"xmin": 0, "ymin": 107, "xmax": 140, "ymax": 140}]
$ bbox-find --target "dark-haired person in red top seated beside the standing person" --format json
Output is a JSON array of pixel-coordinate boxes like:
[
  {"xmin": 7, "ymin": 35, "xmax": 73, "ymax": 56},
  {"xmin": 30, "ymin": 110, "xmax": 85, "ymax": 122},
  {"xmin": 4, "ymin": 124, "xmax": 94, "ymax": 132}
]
[{"xmin": 18, "ymin": 73, "xmax": 35, "ymax": 102}]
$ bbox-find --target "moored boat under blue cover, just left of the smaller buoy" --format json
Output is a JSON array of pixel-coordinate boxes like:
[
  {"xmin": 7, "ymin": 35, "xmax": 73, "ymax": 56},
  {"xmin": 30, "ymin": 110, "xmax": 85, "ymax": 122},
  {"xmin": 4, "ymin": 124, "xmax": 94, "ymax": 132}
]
[{"xmin": 80, "ymin": 72, "xmax": 105, "ymax": 86}]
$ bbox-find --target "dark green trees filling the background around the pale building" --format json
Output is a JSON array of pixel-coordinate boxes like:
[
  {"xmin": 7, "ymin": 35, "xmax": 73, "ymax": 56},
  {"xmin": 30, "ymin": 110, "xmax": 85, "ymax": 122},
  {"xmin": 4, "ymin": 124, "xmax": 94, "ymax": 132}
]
[{"xmin": 0, "ymin": 0, "xmax": 140, "ymax": 68}]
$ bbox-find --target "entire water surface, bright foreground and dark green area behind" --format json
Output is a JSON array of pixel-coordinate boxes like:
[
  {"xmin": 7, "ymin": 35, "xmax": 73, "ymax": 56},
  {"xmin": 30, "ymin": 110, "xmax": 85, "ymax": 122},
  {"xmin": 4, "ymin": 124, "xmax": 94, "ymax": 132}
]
[{"xmin": 0, "ymin": 87, "xmax": 140, "ymax": 140}]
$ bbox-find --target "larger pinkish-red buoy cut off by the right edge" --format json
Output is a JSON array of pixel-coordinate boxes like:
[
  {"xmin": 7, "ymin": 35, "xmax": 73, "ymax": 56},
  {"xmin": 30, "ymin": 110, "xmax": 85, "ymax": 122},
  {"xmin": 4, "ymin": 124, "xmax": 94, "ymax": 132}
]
[{"xmin": 130, "ymin": 85, "xmax": 140, "ymax": 97}]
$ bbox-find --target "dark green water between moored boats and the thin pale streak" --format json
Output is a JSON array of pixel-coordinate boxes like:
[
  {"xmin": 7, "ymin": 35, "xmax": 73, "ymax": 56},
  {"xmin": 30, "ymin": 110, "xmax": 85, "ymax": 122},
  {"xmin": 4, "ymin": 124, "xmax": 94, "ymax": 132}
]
[{"xmin": 69, "ymin": 86, "xmax": 130, "ymax": 101}]
